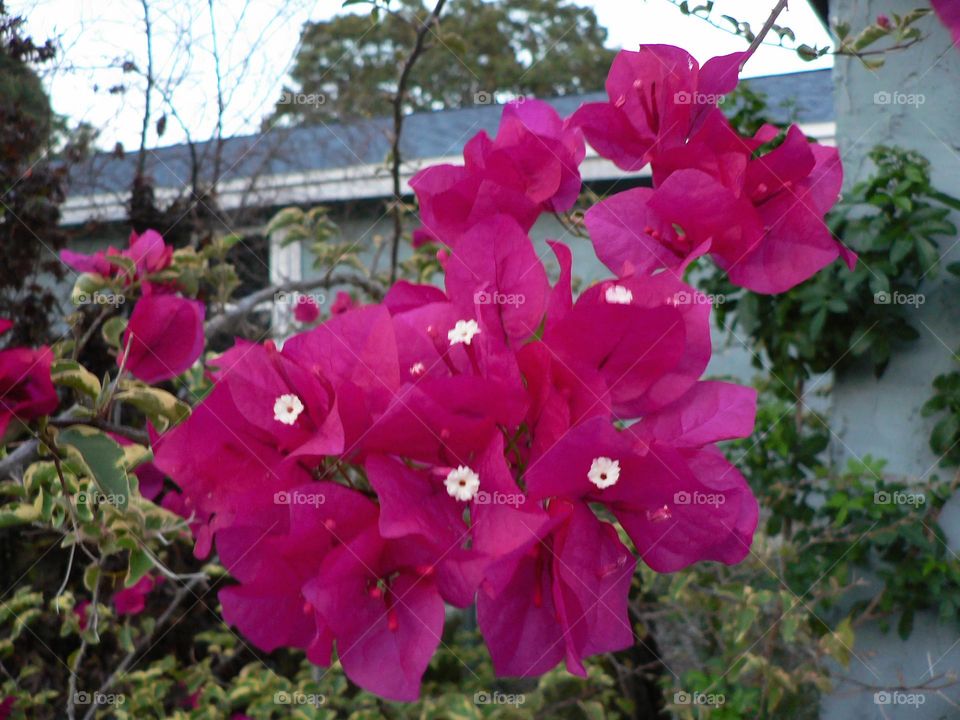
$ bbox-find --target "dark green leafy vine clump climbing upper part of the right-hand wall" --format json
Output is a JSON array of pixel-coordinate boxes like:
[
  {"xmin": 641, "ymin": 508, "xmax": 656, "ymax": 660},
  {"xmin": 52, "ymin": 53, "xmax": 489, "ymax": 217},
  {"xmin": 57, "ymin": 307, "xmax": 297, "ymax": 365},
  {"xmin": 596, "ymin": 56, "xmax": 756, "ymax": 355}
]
[{"xmin": 706, "ymin": 147, "xmax": 960, "ymax": 397}]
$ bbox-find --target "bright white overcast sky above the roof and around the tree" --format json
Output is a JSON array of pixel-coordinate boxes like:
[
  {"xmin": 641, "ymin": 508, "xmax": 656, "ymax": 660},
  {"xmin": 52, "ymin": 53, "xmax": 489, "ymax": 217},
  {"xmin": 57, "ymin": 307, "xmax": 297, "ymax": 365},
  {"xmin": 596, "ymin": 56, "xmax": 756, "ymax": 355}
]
[{"xmin": 7, "ymin": 0, "xmax": 831, "ymax": 150}]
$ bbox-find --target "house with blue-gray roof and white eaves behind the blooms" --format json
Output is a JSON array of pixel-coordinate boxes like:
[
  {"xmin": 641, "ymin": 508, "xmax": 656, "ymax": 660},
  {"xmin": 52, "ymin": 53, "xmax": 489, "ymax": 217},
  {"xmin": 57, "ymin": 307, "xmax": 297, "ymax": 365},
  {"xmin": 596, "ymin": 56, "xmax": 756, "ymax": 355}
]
[{"xmin": 63, "ymin": 70, "xmax": 835, "ymax": 346}]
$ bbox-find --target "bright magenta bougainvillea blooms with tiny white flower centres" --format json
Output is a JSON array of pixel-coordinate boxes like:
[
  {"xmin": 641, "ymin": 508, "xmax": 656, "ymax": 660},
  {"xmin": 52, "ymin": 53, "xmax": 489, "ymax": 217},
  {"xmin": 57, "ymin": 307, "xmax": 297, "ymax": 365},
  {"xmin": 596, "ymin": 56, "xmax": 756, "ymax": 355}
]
[{"xmin": 0, "ymin": 45, "xmax": 855, "ymax": 701}]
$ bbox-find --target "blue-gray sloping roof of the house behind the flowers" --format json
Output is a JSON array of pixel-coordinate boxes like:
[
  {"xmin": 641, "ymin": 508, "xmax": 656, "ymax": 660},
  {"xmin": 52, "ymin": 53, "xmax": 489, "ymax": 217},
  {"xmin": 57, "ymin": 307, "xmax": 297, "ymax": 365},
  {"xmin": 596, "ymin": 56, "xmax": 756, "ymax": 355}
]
[{"xmin": 69, "ymin": 70, "xmax": 834, "ymax": 197}]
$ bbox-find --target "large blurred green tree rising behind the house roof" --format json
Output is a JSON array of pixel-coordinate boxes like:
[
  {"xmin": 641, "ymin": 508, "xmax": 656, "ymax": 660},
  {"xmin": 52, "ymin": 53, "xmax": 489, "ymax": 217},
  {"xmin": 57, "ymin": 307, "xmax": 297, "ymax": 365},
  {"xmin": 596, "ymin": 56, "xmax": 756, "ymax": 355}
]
[{"xmin": 276, "ymin": 0, "xmax": 614, "ymax": 124}]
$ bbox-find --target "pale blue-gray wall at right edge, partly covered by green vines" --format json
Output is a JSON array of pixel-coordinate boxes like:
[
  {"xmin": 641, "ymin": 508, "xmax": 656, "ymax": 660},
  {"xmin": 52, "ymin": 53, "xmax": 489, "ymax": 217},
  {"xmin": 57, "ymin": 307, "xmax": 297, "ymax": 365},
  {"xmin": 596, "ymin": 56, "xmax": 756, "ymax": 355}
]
[{"xmin": 822, "ymin": 0, "xmax": 960, "ymax": 720}]
